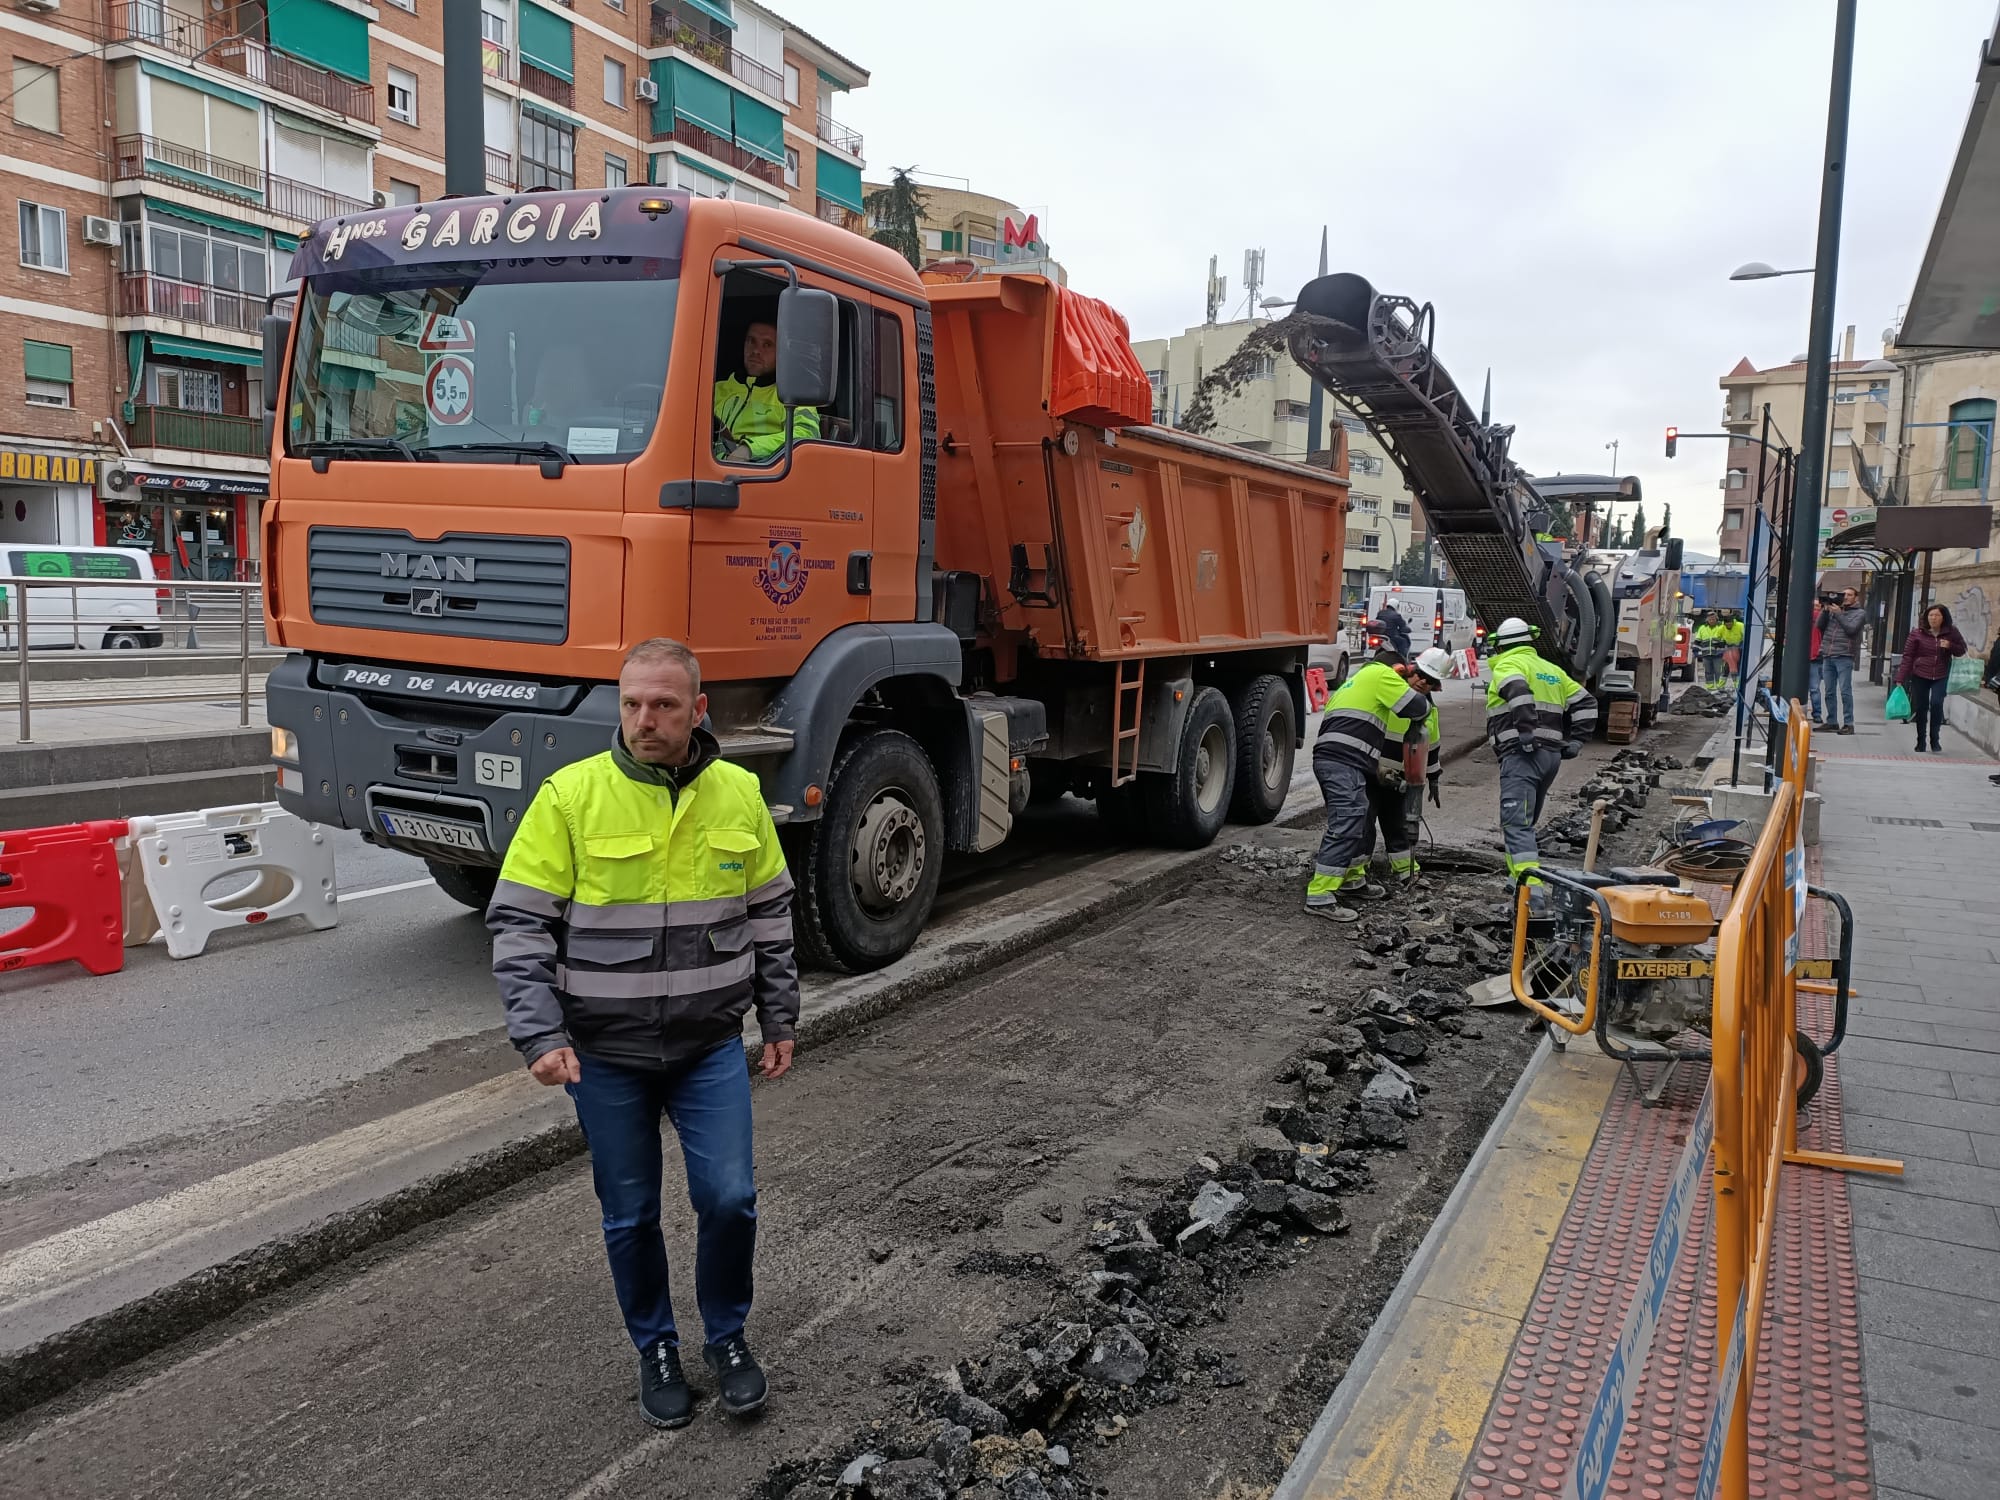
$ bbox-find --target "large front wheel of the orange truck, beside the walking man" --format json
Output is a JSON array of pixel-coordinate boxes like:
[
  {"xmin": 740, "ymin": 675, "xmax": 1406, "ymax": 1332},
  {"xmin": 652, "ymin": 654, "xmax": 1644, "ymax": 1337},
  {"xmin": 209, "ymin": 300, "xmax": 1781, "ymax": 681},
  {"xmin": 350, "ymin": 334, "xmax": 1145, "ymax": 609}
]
[{"xmin": 792, "ymin": 730, "xmax": 944, "ymax": 974}]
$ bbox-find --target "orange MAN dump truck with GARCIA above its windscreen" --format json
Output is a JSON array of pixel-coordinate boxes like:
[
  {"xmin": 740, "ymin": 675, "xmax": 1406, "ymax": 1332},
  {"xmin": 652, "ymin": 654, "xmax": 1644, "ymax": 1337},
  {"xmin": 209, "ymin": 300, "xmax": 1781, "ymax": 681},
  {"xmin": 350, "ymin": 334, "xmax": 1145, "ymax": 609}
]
[{"xmin": 264, "ymin": 188, "xmax": 1346, "ymax": 968}]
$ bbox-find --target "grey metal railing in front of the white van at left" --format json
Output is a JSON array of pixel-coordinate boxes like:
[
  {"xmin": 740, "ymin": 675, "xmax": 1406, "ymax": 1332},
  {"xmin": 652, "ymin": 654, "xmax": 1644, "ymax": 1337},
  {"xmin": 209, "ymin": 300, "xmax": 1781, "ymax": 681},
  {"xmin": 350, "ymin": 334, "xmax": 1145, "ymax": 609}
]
[{"xmin": 0, "ymin": 576, "xmax": 264, "ymax": 744}]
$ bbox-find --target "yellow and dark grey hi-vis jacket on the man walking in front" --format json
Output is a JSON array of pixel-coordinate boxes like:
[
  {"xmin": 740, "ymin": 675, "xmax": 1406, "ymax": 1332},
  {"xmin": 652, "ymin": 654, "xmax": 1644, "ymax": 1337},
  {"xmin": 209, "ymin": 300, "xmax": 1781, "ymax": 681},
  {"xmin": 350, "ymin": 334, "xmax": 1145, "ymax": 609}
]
[{"xmin": 486, "ymin": 746, "xmax": 798, "ymax": 1068}]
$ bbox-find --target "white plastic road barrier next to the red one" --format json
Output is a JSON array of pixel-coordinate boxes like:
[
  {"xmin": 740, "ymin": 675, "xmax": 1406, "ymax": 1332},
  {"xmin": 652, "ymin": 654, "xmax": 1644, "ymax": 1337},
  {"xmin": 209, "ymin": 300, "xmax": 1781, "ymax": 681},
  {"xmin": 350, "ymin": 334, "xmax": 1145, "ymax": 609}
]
[{"xmin": 126, "ymin": 802, "xmax": 340, "ymax": 958}]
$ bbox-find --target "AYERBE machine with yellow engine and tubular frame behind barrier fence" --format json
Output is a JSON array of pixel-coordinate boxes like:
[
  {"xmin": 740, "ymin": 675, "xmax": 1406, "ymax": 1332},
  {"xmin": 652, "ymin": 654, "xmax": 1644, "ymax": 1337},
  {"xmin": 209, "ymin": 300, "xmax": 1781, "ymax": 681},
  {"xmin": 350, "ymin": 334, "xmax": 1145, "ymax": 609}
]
[{"xmin": 1510, "ymin": 868, "xmax": 1854, "ymax": 1108}]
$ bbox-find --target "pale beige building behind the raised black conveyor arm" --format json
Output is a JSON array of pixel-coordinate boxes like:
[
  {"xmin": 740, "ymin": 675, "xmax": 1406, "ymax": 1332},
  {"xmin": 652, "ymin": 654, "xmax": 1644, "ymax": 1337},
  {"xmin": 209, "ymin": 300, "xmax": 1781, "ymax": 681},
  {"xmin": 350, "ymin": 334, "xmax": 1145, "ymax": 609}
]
[{"xmin": 1132, "ymin": 318, "xmax": 1424, "ymax": 604}]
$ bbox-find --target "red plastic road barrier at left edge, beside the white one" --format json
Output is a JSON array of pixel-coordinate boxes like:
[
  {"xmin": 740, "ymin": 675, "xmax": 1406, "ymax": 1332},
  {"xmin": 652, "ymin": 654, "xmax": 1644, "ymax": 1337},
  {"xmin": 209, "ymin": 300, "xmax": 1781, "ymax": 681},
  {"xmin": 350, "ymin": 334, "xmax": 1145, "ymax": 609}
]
[{"xmin": 0, "ymin": 820, "xmax": 126, "ymax": 974}]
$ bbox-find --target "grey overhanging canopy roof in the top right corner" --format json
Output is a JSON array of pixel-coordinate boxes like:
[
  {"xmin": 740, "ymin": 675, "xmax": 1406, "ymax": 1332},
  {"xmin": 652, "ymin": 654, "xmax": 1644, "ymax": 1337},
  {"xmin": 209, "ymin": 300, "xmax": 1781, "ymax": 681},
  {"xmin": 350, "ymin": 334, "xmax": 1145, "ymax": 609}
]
[{"xmin": 1896, "ymin": 6, "xmax": 2000, "ymax": 348}]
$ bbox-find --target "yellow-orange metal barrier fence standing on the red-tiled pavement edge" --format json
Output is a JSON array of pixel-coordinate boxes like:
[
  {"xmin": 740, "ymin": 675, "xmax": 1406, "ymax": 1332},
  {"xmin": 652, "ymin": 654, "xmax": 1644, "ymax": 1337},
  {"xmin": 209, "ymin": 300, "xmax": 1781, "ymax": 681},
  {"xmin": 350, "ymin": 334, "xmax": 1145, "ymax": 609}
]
[{"xmin": 1696, "ymin": 702, "xmax": 1902, "ymax": 1500}]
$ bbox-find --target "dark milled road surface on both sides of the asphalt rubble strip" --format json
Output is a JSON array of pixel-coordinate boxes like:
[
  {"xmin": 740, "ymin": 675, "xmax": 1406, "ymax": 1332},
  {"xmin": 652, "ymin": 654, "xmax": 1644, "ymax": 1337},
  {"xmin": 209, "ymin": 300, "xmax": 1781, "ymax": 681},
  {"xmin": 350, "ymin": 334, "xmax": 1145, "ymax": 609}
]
[{"xmin": 0, "ymin": 722, "xmax": 1710, "ymax": 1500}]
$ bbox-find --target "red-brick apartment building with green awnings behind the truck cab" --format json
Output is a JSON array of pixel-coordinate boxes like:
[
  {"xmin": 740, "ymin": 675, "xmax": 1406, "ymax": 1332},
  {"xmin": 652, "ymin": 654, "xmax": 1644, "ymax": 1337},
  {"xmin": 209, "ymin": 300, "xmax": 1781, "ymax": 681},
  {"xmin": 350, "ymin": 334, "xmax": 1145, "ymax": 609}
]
[{"xmin": 0, "ymin": 0, "xmax": 868, "ymax": 578}]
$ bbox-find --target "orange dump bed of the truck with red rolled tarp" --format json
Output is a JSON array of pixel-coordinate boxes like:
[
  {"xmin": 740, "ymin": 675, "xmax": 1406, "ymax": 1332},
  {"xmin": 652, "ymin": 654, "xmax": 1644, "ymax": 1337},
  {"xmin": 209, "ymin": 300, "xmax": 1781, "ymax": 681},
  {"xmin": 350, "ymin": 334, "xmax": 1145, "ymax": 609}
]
[{"xmin": 926, "ymin": 276, "xmax": 1348, "ymax": 660}]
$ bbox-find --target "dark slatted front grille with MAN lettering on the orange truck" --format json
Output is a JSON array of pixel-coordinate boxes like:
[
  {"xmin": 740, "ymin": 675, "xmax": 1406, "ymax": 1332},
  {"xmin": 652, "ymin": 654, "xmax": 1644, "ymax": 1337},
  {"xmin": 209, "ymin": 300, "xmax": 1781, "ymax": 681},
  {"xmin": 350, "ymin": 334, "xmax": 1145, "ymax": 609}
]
[{"xmin": 306, "ymin": 526, "xmax": 570, "ymax": 646}]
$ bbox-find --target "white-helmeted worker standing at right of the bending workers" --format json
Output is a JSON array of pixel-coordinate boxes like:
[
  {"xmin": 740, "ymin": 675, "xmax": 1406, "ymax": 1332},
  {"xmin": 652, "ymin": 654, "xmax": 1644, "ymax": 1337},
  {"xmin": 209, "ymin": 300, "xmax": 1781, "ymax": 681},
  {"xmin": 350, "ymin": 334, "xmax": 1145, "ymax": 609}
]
[{"xmin": 1486, "ymin": 618, "xmax": 1598, "ymax": 884}]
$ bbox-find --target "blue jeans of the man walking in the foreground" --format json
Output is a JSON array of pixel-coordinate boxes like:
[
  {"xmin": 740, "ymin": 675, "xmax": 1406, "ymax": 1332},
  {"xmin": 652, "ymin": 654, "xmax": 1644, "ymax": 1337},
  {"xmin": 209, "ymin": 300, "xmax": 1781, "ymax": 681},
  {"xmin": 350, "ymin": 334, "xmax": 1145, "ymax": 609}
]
[{"xmin": 564, "ymin": 1036, "xmax": 756, "ymax": 1352}]
